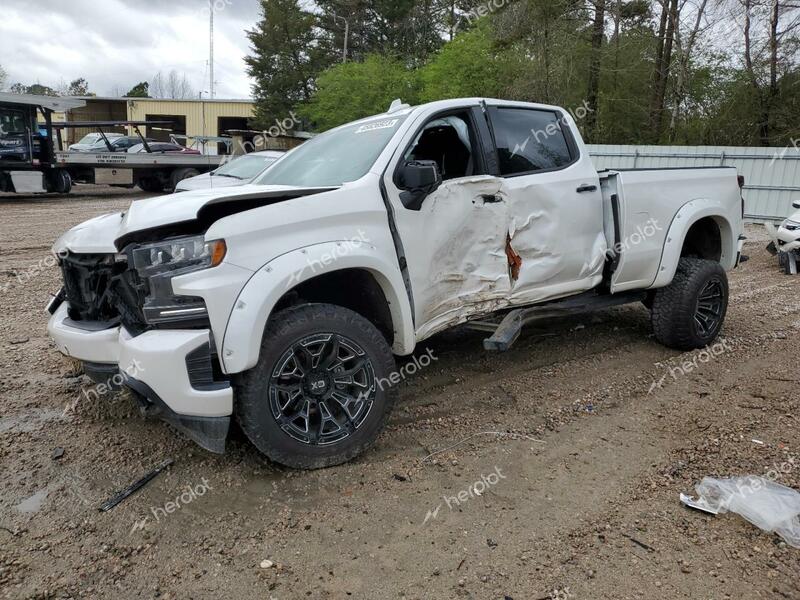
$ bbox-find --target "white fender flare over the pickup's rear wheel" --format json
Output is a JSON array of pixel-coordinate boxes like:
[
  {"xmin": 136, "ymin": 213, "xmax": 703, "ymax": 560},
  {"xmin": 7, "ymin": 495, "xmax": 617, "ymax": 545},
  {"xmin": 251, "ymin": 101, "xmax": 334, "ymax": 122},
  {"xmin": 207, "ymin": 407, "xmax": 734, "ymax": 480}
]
[{"xmin": 648, "ymin": 198, "xmax": 738, "ymax": 289}]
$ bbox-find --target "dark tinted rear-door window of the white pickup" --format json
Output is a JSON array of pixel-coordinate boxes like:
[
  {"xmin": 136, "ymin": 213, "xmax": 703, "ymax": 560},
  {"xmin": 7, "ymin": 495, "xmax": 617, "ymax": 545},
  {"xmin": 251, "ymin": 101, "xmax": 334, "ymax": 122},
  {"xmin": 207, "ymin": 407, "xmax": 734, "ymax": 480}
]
[{"xmin": 491, "ymin": 108, "xmax": 572, "ymax": 175}]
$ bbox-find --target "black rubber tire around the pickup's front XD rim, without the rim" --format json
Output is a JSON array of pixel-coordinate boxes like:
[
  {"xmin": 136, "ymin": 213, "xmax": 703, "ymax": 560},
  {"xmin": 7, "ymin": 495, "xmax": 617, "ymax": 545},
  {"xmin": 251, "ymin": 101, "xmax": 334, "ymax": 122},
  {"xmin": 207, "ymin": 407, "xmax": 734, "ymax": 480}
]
[{"xmin": 234, "ymin": 304, "xmax": 397, "ymax": 469}]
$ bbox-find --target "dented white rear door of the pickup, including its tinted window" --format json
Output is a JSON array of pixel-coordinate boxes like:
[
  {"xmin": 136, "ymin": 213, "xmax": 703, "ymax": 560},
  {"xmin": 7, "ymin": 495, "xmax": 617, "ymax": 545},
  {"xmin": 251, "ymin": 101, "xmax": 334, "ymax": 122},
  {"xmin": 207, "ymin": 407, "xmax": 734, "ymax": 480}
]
[{"xmin": 488, "ymin": 105, "xmax": 608, "ymax": 304}]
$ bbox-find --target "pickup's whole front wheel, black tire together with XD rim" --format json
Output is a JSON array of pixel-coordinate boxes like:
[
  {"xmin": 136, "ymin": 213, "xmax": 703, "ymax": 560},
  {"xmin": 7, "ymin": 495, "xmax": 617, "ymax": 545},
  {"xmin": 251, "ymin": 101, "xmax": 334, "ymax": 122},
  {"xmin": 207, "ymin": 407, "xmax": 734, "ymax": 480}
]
[{"xmin": 235, "ymin": 304, "xmax": 397, "ymax": 469}]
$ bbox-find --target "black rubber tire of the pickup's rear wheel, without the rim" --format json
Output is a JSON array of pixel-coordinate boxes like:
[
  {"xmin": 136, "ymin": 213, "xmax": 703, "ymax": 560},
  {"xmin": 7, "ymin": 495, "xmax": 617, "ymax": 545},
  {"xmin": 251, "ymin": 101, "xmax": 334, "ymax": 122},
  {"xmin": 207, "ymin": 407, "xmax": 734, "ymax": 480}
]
[{"xmin": 650, "ymin": 257, "xmax": 728, "ymax": 351}]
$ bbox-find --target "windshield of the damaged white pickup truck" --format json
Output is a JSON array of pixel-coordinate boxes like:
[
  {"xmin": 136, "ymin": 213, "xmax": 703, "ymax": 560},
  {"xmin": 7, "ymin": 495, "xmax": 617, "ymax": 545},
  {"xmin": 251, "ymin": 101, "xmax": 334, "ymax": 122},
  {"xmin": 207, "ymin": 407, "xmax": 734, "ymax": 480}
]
[{"xmin": 253, "ymin": 115, "xmax": 406, "ymax": 187}]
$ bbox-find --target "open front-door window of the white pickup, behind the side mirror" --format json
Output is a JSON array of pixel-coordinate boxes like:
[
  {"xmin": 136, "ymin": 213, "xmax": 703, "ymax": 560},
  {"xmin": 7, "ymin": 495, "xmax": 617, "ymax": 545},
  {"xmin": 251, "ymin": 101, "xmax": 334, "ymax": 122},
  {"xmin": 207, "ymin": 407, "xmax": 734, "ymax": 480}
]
[{"xmin": 404, "ymin": 115, "xmax": 478, "ymax": 180}]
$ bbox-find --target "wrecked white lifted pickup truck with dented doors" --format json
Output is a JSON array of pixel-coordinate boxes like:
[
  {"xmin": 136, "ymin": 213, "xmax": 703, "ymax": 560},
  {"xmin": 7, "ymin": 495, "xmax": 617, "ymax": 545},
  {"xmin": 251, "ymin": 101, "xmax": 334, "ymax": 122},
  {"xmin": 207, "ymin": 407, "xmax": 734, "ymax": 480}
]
[{"xmin": 48, "ymin": 98, "xmax": 743, "ymax": 468}]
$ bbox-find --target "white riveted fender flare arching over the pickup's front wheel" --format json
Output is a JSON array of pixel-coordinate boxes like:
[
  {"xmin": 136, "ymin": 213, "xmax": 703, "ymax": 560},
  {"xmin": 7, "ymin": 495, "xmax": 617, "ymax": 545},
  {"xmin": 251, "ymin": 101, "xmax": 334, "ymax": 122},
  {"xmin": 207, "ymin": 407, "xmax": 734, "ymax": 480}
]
[{"xmin": 220, "ymin": 240, "xmax": 416, "ymax": 374}]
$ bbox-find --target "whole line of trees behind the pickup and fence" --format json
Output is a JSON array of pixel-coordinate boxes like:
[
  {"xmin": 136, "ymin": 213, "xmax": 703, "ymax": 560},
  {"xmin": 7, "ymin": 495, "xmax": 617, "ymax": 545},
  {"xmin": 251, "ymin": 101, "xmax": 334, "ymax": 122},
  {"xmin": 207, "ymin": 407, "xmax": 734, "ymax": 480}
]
[{"xmin": 246, "ymin": 0, "xmax": 800, "ymax": 146}]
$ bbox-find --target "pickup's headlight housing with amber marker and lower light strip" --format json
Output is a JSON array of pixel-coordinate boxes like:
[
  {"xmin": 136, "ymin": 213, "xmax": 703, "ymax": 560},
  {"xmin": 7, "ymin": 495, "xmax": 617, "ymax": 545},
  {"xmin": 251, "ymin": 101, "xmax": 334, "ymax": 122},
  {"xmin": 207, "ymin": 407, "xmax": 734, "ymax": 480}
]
[{"xmin": 132, "ymin": 235, "xmax": 227, "ymax": 325}]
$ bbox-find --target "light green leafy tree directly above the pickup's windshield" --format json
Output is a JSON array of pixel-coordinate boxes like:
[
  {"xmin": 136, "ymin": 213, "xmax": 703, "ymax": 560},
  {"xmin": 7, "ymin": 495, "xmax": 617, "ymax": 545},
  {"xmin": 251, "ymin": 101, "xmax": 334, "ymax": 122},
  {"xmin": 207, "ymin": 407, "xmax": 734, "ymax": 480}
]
[{"xmin": 300, "ymin": 54, "xmax": 418, "ymax": 131}]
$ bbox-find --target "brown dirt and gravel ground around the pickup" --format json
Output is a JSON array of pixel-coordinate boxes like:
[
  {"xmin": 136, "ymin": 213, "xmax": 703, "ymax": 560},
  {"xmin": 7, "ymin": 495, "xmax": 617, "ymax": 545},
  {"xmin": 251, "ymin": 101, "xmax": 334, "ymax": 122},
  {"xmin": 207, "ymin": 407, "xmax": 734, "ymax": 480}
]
[{"xmin": 0, "ymin": 188, "xmax": 800, "ymax": 600}]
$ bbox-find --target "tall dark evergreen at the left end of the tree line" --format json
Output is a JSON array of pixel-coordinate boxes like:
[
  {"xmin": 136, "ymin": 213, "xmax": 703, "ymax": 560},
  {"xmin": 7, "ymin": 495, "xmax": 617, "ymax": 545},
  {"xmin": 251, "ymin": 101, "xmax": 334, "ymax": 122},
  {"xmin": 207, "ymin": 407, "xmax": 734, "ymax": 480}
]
[{"xmin": 245, "ymin": 0, "xmax": 335, "ymax": 129}]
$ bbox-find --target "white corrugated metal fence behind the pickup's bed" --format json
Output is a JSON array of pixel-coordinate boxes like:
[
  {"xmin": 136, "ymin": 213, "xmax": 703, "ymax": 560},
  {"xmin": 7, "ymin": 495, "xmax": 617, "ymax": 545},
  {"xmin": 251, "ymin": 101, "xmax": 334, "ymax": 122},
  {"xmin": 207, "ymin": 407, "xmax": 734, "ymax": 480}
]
[{"xmin": 589, "ymin": 144, "xmax": 800, "ymax": 222}]
